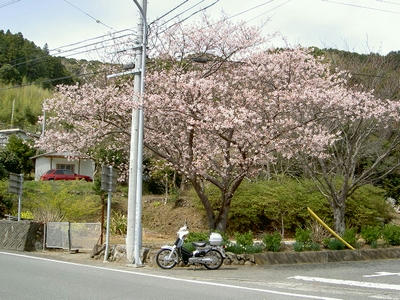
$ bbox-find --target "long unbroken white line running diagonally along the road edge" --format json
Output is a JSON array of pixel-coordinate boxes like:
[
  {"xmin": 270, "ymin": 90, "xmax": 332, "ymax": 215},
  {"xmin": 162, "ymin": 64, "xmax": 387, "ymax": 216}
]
[{"xmin": 0, "ymin": 251, "xmax": 341, "ymax": 300}]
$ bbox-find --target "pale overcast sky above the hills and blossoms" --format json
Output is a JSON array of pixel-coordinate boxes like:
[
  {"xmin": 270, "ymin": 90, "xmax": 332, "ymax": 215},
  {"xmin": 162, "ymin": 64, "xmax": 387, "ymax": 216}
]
[{"xmin": 0, "ymin": 0, "xmax": 400, "ymax": 59}]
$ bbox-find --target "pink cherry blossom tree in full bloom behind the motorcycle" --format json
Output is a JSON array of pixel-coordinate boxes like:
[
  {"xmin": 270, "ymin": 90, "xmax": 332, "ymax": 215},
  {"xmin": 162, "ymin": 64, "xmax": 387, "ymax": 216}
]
[{"xmin": 39, "ymin": 19, "xmax": 396, "ymax": 231}]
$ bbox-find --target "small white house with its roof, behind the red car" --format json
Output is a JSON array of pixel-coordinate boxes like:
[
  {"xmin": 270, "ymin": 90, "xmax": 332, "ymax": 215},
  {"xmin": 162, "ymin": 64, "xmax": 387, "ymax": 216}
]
[{"xmin": 31, "ymin": 152, "xmax": 95, "ymax": 180}]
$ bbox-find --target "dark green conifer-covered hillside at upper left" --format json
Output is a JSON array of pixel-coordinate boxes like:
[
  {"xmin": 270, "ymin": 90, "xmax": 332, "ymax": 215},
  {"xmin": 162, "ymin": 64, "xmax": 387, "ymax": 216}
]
[{"xmin": 0, "ymin": 30, "xmax": 74, "ymax": 88}]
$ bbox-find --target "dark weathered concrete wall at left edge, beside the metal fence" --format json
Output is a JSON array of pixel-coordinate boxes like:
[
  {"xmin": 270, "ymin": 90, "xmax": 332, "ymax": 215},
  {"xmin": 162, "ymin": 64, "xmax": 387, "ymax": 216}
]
[{"xmin": 0, "ymin": 220, "xmax": 43, "ymax": 251}]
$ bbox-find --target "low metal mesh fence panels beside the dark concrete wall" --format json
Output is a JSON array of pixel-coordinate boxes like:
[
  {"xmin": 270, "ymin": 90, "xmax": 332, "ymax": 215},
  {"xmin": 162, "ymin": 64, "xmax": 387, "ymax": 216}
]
[{"xmin": 46, "ymin": 222, "xmax": 101, "ymax": 250}]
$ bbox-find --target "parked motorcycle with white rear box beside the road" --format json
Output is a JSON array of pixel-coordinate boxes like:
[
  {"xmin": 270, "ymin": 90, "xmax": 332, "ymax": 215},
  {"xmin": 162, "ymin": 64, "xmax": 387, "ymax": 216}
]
[{"xmin": 156, "ymin": 224, "xmax": 226, "ymax": 270}]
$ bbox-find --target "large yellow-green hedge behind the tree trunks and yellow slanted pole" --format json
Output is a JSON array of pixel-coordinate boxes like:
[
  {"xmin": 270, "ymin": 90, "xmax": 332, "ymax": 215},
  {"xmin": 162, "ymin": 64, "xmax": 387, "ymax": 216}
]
[{"xmin": 216, "ymin": 177, "xmax": 391, "ymax": 233}]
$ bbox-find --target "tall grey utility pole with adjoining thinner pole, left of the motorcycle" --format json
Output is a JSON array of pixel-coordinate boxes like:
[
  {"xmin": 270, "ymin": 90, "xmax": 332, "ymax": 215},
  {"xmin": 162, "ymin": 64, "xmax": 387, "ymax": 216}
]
[{"xmin": 126, "ymin": 0, "xmax": 147, "ymax": 266}]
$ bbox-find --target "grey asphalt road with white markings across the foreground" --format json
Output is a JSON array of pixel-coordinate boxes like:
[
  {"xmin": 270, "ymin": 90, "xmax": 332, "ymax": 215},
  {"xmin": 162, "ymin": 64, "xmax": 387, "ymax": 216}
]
[{"xmin": 0, "ymin": 251, "xmax": 400, "ymax": 300}]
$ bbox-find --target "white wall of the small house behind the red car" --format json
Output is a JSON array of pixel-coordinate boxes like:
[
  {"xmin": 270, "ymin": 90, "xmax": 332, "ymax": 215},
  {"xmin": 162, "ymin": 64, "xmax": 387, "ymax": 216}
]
[{"xmin": 35, "ymin": 156, "xmax": 95, "ymax": 180}]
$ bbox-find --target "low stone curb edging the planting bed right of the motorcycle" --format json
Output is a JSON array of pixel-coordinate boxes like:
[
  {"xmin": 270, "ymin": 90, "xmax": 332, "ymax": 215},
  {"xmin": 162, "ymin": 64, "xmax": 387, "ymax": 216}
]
[{"xmin": 254, "ymin": 247, "xmax": 400, "ymax": 265}]
